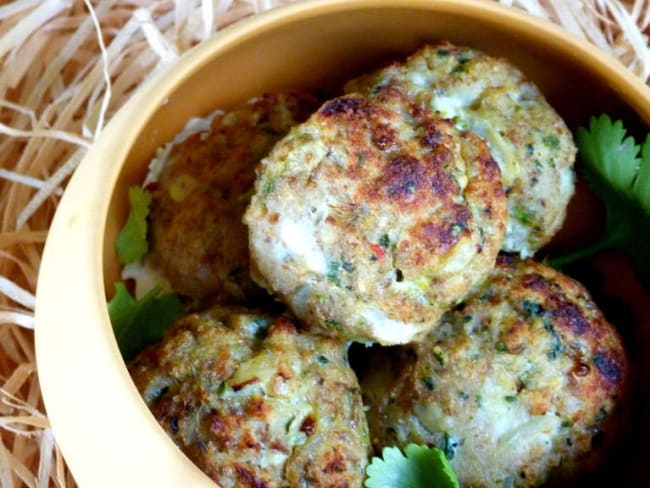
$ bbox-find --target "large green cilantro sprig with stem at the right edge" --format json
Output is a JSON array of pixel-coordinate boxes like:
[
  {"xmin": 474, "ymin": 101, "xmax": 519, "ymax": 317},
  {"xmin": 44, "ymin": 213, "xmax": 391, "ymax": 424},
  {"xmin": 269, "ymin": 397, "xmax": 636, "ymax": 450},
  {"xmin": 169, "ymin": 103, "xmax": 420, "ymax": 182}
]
[{"xmin": 551, "ymin": 115, "xmax": 650, "ymax": 290}]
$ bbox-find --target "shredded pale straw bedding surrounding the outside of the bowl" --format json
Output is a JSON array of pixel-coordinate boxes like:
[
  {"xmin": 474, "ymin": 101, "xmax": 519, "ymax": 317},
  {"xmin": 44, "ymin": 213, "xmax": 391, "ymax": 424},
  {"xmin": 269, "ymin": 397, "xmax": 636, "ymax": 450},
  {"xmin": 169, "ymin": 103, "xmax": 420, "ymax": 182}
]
[{"xmin": 0, "ymin": 0, "xmax": 650, "ymax": 488}]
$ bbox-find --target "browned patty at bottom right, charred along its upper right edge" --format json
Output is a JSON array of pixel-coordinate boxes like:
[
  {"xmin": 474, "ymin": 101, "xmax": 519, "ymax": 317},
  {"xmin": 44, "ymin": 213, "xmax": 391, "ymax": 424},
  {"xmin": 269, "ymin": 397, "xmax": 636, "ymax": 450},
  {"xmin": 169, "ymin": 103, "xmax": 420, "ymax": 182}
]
[{"xmin": 361, "ymin": 257, "xmax": 629, "ymax": 488}]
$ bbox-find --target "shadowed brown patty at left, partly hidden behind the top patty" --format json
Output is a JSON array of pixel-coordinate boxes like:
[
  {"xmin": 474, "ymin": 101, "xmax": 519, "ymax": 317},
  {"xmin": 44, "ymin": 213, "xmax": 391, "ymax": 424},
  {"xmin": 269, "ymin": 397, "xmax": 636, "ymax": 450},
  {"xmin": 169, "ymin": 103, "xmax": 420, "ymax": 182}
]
[{"xmin": 148, "ymin": 89, "xmax": 318, "ymax": 302}]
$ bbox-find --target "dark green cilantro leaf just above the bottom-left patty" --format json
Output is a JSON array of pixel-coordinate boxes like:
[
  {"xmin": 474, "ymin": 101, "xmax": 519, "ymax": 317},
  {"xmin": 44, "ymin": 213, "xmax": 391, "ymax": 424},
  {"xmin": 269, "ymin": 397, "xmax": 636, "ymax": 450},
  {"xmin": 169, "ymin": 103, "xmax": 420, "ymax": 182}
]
[{"xmin": 108, "ymin": 283, "xmax": 184, "ymax": 361}]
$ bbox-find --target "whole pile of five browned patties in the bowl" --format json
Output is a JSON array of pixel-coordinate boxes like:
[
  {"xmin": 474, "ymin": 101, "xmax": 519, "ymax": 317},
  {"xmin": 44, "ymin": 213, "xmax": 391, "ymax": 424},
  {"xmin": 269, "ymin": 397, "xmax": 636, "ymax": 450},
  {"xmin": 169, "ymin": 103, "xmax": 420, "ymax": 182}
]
[{"xmin": 126, "ymin": 43, "xmax": 628, "ymax": 488}]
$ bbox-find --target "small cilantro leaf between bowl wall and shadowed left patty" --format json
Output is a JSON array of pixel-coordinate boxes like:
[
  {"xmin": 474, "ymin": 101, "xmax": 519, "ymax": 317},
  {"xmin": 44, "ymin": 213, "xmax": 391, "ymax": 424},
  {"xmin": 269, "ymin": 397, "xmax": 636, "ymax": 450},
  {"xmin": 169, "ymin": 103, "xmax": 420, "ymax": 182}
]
[{"xmin": 115, "ymin": 186, "xmax": 151, "ymax": 264}]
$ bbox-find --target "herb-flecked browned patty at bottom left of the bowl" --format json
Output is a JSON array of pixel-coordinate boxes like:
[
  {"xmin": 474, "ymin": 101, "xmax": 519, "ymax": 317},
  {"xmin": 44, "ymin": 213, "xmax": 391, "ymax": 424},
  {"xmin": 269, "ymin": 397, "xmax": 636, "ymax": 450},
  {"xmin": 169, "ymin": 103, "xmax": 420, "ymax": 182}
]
[{"xmin": 129, "ymin": 308, "xmax": 370, "ymax": 488}]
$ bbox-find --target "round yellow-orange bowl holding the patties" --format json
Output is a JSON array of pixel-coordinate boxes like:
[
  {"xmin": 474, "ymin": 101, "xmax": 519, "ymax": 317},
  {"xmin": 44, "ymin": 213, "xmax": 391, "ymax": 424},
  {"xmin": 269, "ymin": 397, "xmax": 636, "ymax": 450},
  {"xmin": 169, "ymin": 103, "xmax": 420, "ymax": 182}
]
[{"xmin": 36, "ymin": 0, "xmax": 650, "ymax": 488}]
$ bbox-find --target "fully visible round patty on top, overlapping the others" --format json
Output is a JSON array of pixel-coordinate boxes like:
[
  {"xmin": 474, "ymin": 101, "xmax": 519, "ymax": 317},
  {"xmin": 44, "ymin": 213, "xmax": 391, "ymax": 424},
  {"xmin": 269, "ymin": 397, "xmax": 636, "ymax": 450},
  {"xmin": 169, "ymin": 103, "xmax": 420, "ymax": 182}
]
[{"xmin": 245, "ymin": 88, "xmax": 506, "ymax": 344}]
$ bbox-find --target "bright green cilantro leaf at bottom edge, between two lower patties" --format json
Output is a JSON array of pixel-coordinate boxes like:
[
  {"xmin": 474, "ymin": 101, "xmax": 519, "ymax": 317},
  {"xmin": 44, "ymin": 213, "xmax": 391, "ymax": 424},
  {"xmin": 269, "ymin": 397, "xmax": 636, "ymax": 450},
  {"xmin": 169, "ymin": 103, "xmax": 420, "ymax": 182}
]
[{"xmin": 365, "ymin": 444, "xmax": 459, "ymax": 488}]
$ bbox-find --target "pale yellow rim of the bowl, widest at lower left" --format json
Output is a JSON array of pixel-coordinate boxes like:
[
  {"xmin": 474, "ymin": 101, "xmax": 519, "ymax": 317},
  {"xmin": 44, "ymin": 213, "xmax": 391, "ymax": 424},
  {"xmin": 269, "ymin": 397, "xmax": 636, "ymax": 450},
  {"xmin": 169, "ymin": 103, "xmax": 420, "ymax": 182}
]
[{"xmin": 35, "ymin": 0, "xmax": 650, "ymax": 488}]
